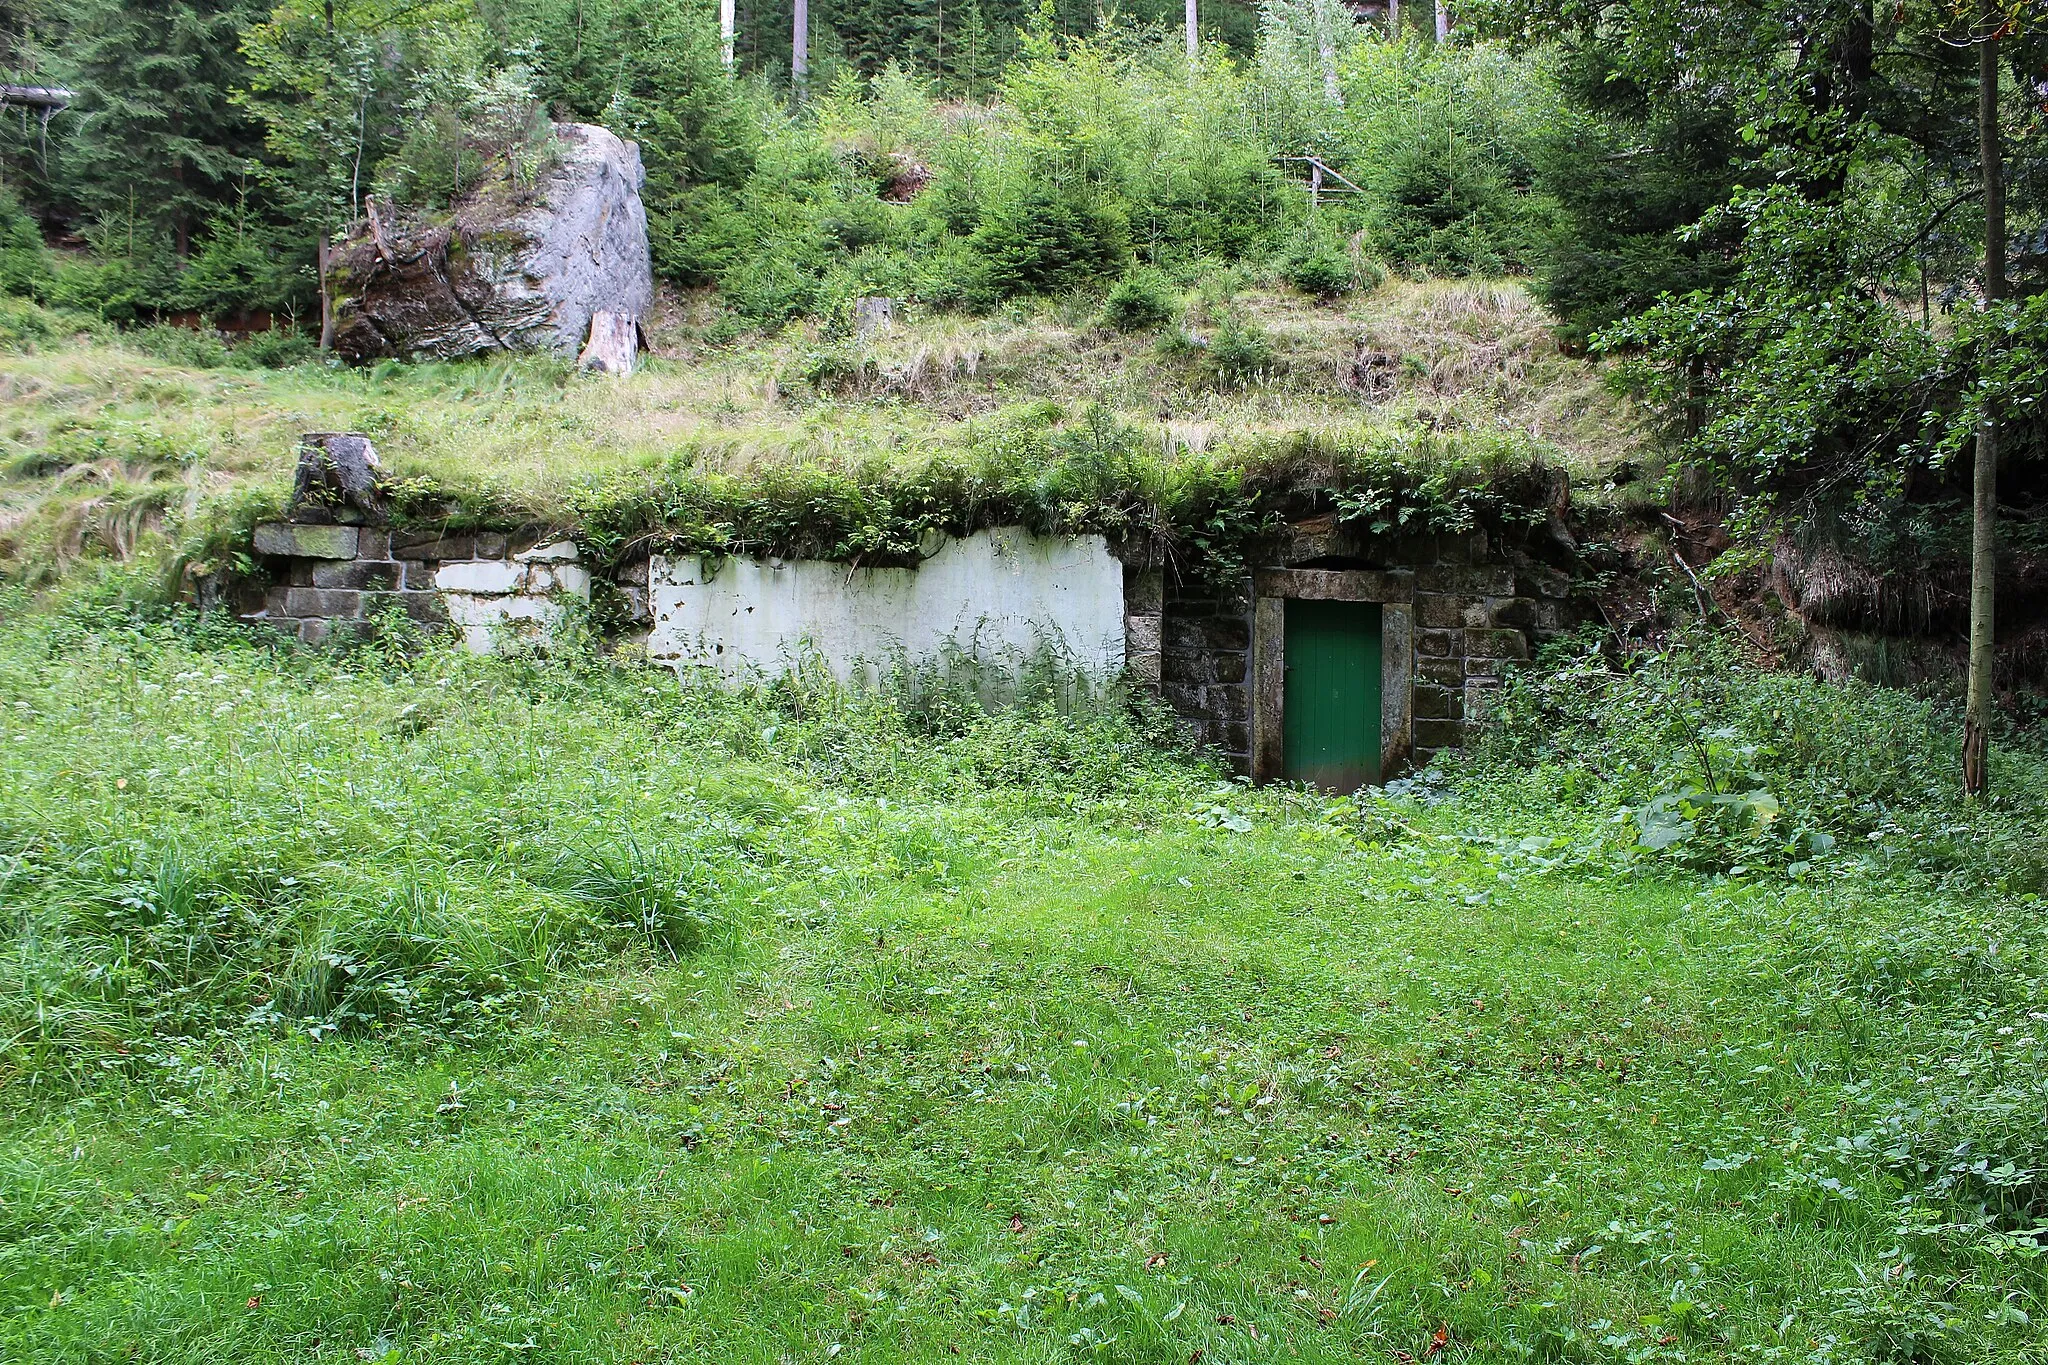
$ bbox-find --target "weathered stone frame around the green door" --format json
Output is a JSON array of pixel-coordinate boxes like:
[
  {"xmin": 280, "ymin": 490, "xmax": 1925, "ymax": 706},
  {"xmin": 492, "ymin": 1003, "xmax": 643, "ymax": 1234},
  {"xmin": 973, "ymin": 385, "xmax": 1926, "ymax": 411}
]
[{"xmin": 1251, "ymin": 569, "xmax": 1415, "ymax": 782}]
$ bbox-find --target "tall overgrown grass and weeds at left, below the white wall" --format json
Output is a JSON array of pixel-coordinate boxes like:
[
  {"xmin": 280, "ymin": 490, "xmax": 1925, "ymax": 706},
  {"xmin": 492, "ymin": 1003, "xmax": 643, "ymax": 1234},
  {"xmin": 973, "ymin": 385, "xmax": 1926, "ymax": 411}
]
[{"xmin": 0, "ymin": 591, "xmax": 1194, "ymax": 1091}]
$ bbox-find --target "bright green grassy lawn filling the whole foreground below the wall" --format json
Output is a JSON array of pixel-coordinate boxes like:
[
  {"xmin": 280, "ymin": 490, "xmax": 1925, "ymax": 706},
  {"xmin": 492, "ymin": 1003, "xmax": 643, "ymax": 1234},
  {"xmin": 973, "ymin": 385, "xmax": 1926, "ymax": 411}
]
[{"xmin": 0, "ymin": 600, "xmax": 2044, "ymax": 1365}]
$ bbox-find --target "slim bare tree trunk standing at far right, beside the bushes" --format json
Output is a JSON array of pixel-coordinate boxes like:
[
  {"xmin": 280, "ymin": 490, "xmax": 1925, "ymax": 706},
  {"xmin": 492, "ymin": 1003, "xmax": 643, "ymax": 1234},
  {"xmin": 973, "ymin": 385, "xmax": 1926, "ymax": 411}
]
[{"xmin": 1962, "ymin": 26, "xmax": 2005, "ymax": 796}]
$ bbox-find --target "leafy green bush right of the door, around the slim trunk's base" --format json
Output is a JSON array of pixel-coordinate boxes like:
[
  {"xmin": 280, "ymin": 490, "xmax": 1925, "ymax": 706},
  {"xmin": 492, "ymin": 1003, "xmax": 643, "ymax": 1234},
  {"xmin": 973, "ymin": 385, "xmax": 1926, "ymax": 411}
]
[{"xmin": 1460, "ymin": 634, "xmax": 2048, "ymax": 892}]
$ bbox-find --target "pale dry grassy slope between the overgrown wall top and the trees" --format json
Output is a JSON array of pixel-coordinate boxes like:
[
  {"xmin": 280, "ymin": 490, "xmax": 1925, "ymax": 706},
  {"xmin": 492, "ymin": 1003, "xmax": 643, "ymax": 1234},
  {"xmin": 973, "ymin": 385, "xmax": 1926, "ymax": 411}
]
[{"xmin": 0, "ymin": 282, "xmax": 1640, "ymax": 577}]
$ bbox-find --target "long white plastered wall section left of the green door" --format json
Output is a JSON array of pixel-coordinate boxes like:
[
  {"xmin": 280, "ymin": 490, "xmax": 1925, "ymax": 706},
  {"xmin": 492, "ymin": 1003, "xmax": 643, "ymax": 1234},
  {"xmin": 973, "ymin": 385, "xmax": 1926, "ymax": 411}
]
[{"xmin": 647, "ymin": 526, "xmax": 1124, "ymax": 679}]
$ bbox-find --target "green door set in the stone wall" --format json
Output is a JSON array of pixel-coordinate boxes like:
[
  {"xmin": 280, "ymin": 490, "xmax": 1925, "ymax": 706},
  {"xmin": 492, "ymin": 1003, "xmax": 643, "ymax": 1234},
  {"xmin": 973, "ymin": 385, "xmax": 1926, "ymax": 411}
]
[{"xmin": 1280, "ymin": 598, "xmax": 1380, "ymax": 792}]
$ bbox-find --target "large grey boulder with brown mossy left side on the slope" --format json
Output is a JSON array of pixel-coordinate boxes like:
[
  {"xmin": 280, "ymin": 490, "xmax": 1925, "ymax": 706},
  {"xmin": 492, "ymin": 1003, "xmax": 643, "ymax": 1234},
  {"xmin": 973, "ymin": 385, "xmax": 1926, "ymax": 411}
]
[{"xmin": 328, "ymin": 123, "xmax": 653, "ymax": 368}]
